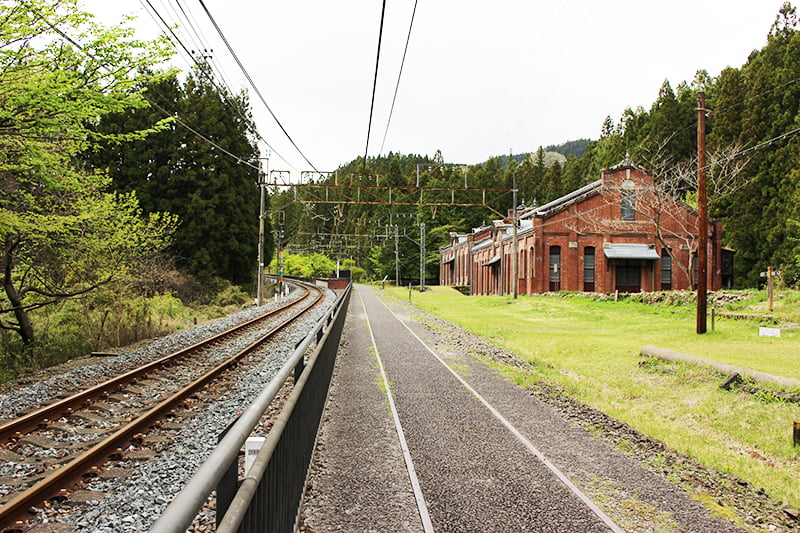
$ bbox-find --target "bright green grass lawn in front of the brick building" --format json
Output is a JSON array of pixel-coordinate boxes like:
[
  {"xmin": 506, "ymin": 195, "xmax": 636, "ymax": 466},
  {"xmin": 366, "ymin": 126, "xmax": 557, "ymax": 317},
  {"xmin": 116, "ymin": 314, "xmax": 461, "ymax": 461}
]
[{"xmin": 387, "ymin": 287, "xmax": 800, "ymax": 507}]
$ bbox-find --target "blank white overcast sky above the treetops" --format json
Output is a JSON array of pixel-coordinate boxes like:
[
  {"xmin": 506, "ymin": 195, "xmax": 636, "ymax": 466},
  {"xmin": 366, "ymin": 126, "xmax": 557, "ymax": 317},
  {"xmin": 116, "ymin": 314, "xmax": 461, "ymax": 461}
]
[{"xmin": 84, "ymin": 0, "xmax": 784, "ymax": 180}]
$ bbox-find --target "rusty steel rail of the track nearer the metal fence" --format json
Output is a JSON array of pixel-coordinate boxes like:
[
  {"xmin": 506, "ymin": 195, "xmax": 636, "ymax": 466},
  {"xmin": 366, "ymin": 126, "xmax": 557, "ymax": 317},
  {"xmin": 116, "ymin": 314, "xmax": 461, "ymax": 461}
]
[{"xmin": 0, "ymin": 282, "xmax": 322, "ymax": 530}]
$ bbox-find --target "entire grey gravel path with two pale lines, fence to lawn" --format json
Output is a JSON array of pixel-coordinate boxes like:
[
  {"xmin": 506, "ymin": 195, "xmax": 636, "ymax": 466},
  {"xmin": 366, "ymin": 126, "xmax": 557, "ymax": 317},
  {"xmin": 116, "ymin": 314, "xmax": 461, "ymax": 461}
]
[{"xmin": 304, "ymin": 287, "xmax": 764, "ymax": 533}]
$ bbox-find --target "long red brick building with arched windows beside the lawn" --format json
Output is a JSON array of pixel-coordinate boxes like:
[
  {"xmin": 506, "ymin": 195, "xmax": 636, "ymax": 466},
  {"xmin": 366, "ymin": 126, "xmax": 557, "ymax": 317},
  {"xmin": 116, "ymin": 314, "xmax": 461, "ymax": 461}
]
[{"xmin": 440, "ymin": 159, "xmax": 723, "ymax": 294}]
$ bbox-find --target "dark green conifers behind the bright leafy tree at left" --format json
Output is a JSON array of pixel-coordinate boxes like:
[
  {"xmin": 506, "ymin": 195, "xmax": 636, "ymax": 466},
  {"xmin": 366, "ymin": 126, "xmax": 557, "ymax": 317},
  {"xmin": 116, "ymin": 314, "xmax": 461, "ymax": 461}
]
[{"xmin": 87, "ymin": 71, "xmax": 262, "ymax": 284}]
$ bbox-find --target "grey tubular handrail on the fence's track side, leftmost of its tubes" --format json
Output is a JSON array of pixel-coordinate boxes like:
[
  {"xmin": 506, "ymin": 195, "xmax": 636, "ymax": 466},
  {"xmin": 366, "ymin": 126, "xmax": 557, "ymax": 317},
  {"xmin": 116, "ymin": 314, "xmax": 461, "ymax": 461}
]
[{"xmin": 150, "ymin": 285, "xmax": 352, "ymax": 533}]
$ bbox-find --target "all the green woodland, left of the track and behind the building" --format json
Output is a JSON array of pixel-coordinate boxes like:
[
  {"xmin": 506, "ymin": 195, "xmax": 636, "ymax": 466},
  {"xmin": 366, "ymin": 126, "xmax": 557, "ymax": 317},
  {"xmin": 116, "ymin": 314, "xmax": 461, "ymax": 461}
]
[{"xmin": 0, "ymin": 0, "xmax": 800, "ymax": 379}]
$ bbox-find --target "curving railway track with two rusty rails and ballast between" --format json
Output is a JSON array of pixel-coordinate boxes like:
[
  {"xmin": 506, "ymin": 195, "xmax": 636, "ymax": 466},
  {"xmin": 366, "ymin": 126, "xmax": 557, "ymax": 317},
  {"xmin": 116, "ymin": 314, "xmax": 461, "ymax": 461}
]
[{"xmin": 0, "ymin": 280, "xmax": 322, "ymax": 531}]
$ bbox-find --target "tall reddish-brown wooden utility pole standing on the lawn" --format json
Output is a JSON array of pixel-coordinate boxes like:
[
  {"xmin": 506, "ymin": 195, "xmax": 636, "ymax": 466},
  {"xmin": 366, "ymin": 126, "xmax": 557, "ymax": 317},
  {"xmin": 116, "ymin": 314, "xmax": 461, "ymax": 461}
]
[{"xmin": 697, "ymin": 91, "xmax": 708, "ymax": 334}]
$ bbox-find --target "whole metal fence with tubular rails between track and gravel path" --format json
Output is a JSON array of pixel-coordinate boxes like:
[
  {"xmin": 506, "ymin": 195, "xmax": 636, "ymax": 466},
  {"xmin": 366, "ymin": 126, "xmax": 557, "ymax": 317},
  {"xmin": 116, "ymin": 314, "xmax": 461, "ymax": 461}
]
[{"xmin": 150, "ymin": 286, "xmax": 352, "ymax": 533}]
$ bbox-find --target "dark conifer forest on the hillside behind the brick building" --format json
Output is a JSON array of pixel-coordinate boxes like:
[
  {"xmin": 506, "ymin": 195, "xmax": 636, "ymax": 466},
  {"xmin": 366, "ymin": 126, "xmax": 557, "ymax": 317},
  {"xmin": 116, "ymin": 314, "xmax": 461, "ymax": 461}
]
[{"xmin": 272, "ymin": 3, "xmax": 800, "ymax": 288}]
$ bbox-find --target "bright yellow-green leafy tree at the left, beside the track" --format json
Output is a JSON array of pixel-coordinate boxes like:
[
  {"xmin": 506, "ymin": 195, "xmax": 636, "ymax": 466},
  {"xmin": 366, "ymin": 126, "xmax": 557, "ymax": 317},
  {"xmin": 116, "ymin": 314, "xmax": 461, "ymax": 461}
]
[{"xmin": 0, "ymin": 0, "xmax": 174, "ymax": 345}]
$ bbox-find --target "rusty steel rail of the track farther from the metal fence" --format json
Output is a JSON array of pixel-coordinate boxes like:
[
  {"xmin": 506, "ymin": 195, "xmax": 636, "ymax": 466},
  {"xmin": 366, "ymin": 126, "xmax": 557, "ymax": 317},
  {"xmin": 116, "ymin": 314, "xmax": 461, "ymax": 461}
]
[{"xmin": 0, "ymin": 287, "xmax": 310, "ymax": 442}]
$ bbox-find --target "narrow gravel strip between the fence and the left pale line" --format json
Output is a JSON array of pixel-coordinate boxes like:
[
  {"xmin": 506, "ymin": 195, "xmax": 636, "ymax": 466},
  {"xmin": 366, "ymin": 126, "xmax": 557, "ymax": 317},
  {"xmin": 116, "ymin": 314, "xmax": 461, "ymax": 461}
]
[{"xmin": 304, "ymin": 293, "xmax": 421, "ymax": 533}]
